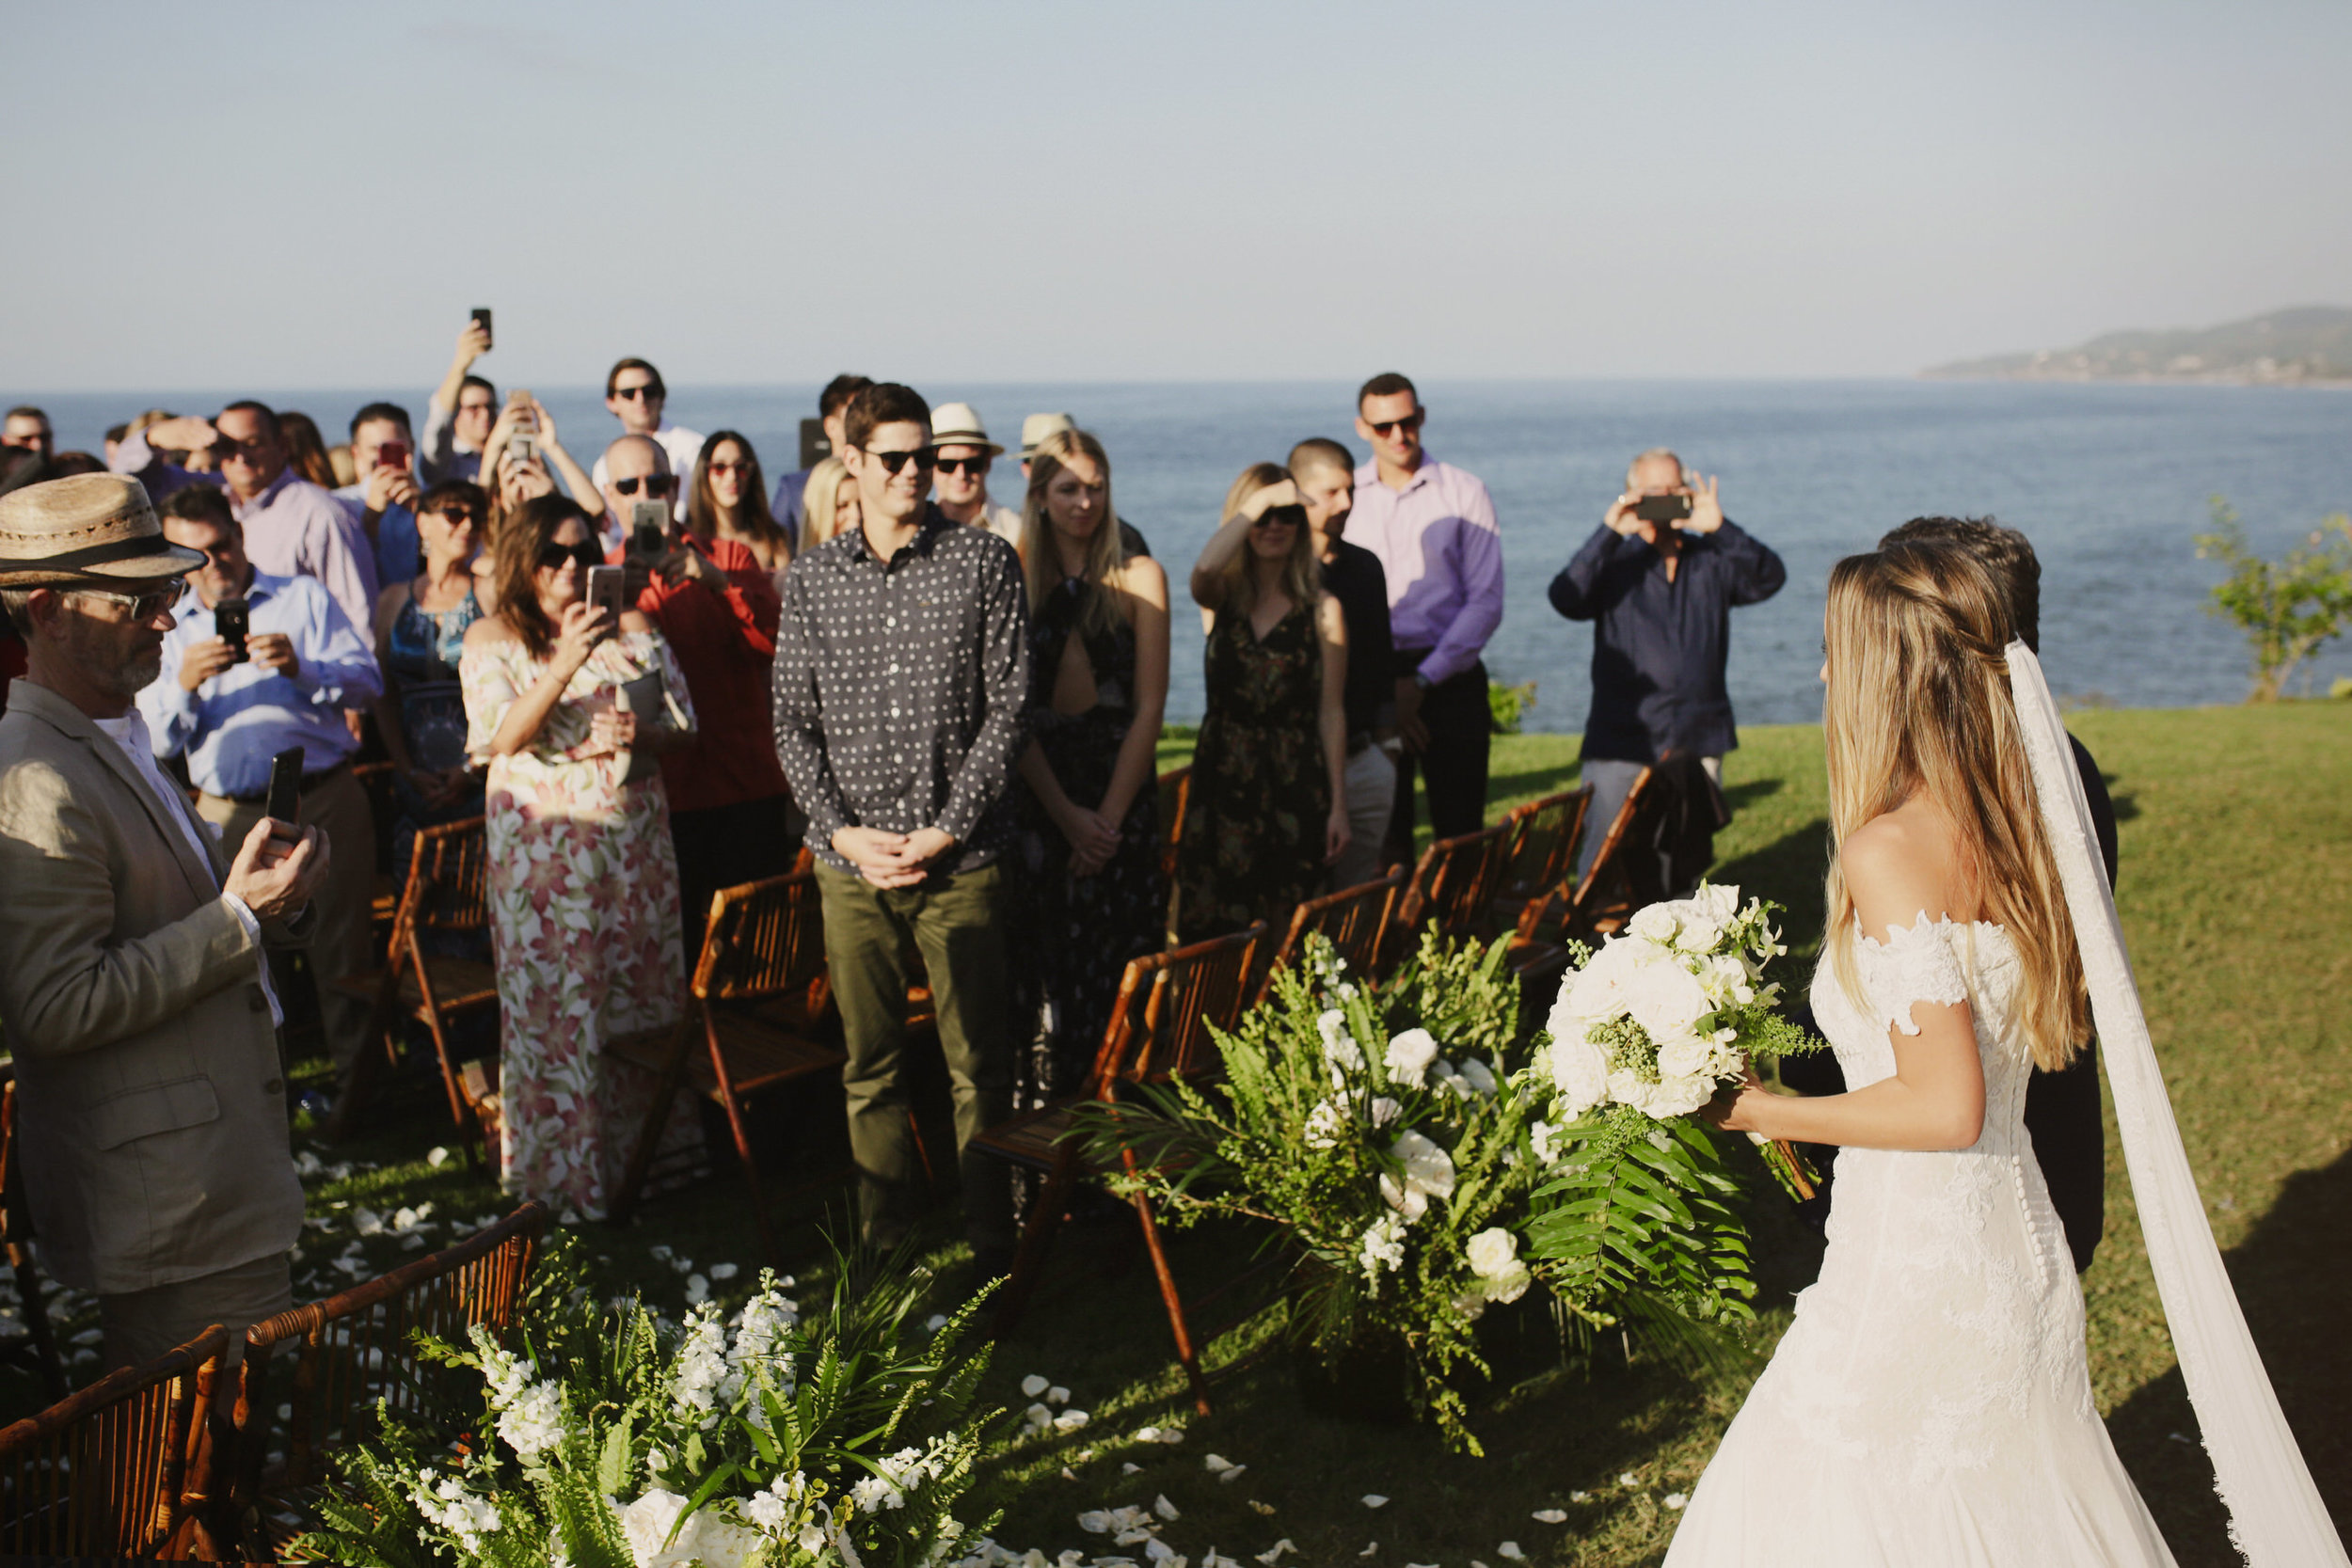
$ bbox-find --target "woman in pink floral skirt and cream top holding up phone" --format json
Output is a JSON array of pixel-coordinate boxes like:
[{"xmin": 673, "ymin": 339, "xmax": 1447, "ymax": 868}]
[{"xmin": 459, "ymin": 496, "xmax": 701, "ymax": 1218}]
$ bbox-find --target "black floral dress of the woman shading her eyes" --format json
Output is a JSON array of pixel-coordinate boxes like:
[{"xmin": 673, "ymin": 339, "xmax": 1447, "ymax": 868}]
[{"xmin": 1176, "ymin": 604, "xmax": 1331, "ymax": 942}]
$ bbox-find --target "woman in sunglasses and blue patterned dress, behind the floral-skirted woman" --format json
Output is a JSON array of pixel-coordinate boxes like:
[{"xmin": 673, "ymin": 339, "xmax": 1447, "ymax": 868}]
[{"xmin": 376, "ymin": 480, "xmax": 489, "ymax": 877}]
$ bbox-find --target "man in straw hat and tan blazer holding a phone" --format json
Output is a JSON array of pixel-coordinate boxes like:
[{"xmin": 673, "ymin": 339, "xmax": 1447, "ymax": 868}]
[{"xmin": 0, "ymin": 475, "xmax": 327, "ymax": 1366}]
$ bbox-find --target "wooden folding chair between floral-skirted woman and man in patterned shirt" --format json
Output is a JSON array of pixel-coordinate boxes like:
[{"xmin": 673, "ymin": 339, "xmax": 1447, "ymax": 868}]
[{"xmin": 605, "ymin": 872, "xmax": 850, "ymax": 1265}]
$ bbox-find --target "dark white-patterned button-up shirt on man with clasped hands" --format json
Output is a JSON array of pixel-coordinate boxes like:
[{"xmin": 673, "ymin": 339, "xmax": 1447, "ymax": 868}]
[{"xmin": 776, "ymin": 508, "xmax": 1028, "ymax": 870}]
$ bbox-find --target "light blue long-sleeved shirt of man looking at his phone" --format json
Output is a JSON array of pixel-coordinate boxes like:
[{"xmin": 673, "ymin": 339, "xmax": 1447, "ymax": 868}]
[{"xmin": 139, "ymin": 571, "xmax": 384, "ymax": 800}]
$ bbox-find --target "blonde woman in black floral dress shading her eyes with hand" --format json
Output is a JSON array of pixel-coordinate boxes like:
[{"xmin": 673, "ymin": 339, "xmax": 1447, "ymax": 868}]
[{"xmin": 1176, "ymin": 463, "xmax": 1348, "ymax": 942}]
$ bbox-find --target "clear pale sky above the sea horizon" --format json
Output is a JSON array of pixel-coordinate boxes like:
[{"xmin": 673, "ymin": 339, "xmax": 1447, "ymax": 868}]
[{"xmin": 0, "ymin": 0, "xmax": 2352, "ymax": 390}]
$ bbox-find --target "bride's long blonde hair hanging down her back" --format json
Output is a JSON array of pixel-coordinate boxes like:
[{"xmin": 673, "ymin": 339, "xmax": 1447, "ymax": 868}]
[{"xmin": 1823, "ymin": 541, "xmax": 2091, "ymax": 1069}]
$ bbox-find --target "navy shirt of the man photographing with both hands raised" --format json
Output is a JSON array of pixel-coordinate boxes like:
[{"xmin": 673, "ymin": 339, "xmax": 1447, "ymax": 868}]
[{"xmin": 1552, "ymin": 519, "xmax": 1788, "ymax": 762}]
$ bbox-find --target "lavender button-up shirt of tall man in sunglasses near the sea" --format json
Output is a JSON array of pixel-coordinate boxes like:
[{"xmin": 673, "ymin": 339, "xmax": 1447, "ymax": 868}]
[{"xmin": 1348, "ymin": 453, "xmax": 1503, "ymax": 687}]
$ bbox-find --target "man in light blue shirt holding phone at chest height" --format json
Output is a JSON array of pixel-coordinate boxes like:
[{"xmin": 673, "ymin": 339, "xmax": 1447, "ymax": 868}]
[{"xmin": 139, "ymin": 489, "xmax": 384, "ymax": 1069}]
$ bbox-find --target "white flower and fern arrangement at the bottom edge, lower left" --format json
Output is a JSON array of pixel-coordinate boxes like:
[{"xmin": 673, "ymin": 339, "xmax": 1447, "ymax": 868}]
[{"xmin": 299, "ymin": 1248, "xmax": 988, "ymax": 1568}]
